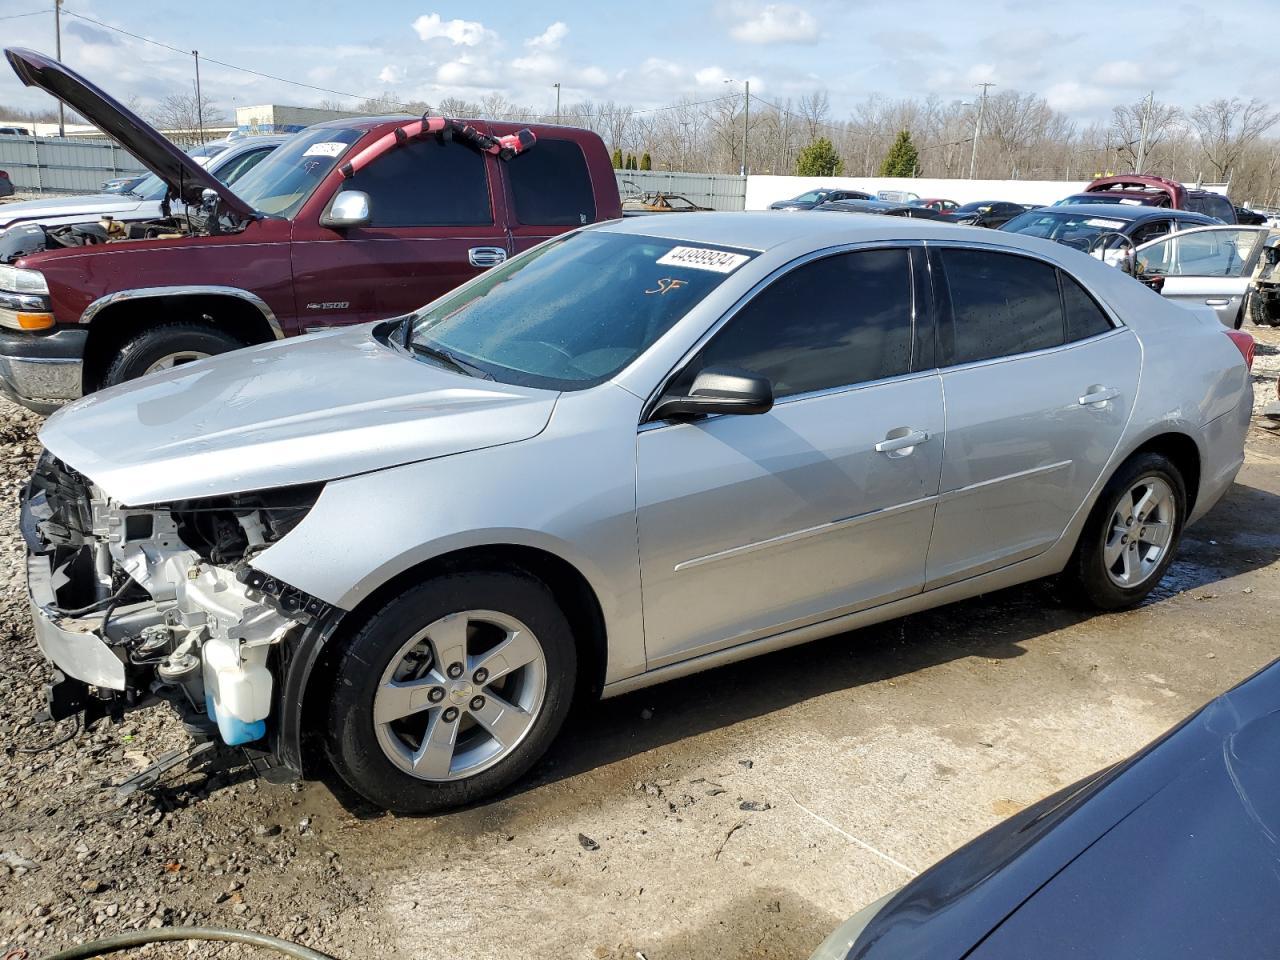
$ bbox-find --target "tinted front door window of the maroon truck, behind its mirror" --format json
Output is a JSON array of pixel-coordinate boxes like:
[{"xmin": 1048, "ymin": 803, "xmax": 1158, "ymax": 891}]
[{"xmin": 343, "ymin": 137, "xmax": 493, "ymax": 227}]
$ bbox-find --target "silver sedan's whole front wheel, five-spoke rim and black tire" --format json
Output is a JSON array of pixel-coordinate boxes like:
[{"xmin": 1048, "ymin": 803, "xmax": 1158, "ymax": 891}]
[{"xmin": 325, "ymin": 572, "xmax": 577, "ymax": 814}]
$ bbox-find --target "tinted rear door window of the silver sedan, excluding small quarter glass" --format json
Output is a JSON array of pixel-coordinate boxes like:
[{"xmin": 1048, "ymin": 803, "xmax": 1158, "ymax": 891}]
[{"xmin": 941, "ymin": 248, "xmax": 1062, "ymax": 364}]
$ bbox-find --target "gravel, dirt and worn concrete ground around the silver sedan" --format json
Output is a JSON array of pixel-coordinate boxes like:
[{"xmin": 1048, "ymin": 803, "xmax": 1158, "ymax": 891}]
[{"xmin": 0, "ymin": 330, "xmax": 1280, "ymax": 960}]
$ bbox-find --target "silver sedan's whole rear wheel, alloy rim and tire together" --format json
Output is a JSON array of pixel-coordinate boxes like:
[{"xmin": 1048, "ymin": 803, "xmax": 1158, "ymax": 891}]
[{"xmin": 1064, "ymin": 453, "xmax": 1187, "ymax": 611}]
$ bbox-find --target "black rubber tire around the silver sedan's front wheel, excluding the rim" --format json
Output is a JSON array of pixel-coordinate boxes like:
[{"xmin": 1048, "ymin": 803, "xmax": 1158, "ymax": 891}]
[{"xmin": 325, "ymin": 571, "xmax": 577, "ymax": 814}]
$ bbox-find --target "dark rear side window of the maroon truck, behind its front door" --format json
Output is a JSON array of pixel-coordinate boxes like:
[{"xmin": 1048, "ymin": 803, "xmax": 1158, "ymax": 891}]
[{"xmin": 506, "ymin": 140, "xmax": 595, "ymax": 227}]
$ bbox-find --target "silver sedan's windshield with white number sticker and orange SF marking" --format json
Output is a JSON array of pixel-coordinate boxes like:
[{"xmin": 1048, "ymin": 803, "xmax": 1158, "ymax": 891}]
[{"xmin": 408, "ymin": 230, "xmax": 755, "ymax": 390}]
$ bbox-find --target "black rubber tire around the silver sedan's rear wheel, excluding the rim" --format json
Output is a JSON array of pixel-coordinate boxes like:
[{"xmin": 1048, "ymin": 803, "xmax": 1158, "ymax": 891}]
[{"xmin": 1062, "ymin": 453, "xmax": 1187, "ymax": 611}]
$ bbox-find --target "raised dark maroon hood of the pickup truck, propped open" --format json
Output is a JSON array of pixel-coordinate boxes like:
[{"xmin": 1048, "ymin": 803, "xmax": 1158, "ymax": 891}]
[{"xmin": 4, "ymin": 47, "xmax": 255, "ymax": 219}]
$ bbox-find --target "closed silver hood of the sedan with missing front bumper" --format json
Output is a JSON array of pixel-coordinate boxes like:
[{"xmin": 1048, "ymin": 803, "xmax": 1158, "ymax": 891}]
[{"xmin": 40, "ymin": 325, "xmax": 558, "ymax": 506}]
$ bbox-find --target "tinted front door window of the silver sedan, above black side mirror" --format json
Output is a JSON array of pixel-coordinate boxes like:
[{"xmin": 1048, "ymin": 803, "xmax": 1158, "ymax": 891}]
[{"xmin": 690, "ymin": 250, "xmax": 911, "ymax": 398}]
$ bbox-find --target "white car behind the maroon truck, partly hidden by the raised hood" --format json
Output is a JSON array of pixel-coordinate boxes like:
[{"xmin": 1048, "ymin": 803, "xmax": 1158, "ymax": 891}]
[{"xmin": 0, "ymin": 136, "xmax": 288, "ymax": 232}]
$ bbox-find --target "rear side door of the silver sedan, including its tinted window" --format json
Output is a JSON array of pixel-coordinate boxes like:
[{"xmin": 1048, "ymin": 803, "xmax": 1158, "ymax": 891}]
[{"xmin": 925, "ymin": 246, "xmax": 1142, "ymax": 589}]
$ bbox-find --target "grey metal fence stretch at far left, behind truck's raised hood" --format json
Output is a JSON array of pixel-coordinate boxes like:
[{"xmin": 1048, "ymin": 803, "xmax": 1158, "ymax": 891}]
[{"xmin": 0, "ymin": 134, "xmax": 146, "ymax": 193}]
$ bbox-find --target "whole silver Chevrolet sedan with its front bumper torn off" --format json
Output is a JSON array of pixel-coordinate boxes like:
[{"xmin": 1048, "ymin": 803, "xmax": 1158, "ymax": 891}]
[{"xmin": 23, "ymin": 214, "xmax": 1252, "ymax": 812}]
